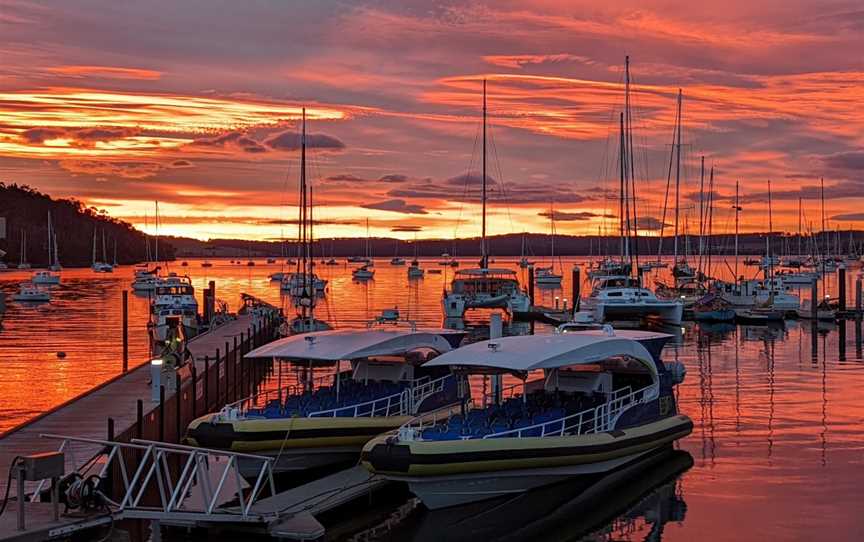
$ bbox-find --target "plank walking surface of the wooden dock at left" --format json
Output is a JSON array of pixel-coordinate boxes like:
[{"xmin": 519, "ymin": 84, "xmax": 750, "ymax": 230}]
[{"xmin": 0, "ymin": 314, "xmax": 252, "ymax": 502}]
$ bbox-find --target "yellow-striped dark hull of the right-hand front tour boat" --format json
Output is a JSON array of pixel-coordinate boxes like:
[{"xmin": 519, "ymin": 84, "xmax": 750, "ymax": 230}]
[{"xmin": 361, "ymin": 415, "xmax": 693, "ymax": 509}]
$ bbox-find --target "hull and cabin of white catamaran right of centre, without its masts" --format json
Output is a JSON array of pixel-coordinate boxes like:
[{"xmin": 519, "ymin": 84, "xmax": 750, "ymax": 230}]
[{"xmin": 585, "ymin": 275, "xmax": 684, "ymax": 324}]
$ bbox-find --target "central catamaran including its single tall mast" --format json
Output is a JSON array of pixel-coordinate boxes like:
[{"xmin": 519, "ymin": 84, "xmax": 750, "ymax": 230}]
[{"xmin": 441, "ymin": 79, "xmax": 531, "ymax": 318}]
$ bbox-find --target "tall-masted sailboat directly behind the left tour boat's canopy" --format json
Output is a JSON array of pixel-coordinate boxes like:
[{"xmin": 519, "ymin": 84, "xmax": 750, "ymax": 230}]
[{"xmin": 280, "ymin": 108, "xmax": 330, "ymax": 314}]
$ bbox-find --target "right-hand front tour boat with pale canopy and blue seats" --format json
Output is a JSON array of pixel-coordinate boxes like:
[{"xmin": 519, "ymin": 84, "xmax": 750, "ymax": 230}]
[{"xmin": 361, "ymin": 326, "xmax": 693, "ymax": 510}]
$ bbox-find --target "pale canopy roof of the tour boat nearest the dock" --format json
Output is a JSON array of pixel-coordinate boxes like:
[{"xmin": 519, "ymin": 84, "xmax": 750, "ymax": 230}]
[{"xmin": 243, "ymin": 328, "xmax": 465, "ymax": 362}]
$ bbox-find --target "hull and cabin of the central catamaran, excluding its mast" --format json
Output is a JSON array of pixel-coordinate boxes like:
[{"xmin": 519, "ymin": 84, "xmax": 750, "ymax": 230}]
[{"xmin": 442, "ymin": 267, "xmax": 531, "ymax": 318}]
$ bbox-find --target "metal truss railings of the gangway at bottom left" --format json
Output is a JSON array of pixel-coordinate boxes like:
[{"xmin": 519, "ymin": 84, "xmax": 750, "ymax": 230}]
[{"xmin": 40, "ymin": 434, "xmax": 276, "ymax": 522}]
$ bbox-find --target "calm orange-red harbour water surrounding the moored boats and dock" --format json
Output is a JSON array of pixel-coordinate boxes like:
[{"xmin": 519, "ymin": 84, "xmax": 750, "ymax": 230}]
[{"xmin": 0, "ymin": 259, "xmax": 864, "ymax": 540}]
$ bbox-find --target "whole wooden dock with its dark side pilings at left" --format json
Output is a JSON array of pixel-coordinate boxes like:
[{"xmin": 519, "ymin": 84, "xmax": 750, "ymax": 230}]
[{"xmin": 0, "ymin": 314, "xmax": 275, "ymax": 540}]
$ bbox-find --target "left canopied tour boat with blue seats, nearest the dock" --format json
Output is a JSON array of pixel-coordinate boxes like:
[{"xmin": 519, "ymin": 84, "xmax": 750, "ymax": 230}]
[{"xmin": 186, "ymin": 325, "xmax": 464, "ymax": 474}]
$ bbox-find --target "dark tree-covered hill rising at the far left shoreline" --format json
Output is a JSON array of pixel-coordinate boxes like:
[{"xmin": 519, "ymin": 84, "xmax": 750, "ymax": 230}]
[{"xmin": 0, "ymin": 183, "xmax": 173, "ymax": 267}]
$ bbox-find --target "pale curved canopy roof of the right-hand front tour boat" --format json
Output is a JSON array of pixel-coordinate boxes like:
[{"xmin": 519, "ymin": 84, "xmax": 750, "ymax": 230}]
[{"xmin": 424, "ymin": 333, "xmax": 657, "ymax": 374}]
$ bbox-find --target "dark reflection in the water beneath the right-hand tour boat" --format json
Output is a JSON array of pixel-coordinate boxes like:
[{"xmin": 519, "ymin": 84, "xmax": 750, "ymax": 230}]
[{"xmin": 376, "ymin": 449, "xmax": 693, "ymax": 542}]
